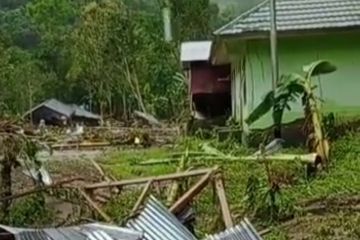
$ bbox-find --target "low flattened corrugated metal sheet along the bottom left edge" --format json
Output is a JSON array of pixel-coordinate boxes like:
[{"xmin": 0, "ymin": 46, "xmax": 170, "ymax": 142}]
[{"xmin": 0, "ymin": 224, "xmax": 142, "ymax": 240}]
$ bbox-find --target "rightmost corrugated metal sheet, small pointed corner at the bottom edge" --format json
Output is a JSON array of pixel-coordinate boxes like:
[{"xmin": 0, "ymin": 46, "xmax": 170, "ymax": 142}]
[{"xmin": 205, "ymin": 218, "xmax": 262, "ymax": 240}]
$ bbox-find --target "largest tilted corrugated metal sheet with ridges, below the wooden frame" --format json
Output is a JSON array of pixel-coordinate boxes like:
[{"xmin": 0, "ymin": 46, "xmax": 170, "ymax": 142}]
[{"xmin": 127, "ymin": 196, "xmax": 196, "ymax": 240}]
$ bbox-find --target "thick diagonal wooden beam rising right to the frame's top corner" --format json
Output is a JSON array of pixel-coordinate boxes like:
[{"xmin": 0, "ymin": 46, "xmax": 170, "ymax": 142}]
[{"xmin": 170, "ymin": 170, "xmax": 214, "ymax": 214}]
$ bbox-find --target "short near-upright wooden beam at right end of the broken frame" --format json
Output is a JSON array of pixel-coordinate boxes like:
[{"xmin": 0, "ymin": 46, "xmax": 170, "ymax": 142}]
[{"xmin": 215, "ymin": 174, "xmax": 234, "ymax": 228}]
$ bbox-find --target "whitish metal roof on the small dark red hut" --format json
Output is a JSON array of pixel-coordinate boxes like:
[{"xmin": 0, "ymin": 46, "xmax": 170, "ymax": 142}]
[{"xmin": 180, "ymin": 41, "xmax": 212, "ymax": 62}]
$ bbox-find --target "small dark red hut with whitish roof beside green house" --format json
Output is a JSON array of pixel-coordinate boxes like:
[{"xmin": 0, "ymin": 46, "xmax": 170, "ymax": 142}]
[{"xmin": 181, "ymin": 41, "xmax": 231, "ymax": 118}]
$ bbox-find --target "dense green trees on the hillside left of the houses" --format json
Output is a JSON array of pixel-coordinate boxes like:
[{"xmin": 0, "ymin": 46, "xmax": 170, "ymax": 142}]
[{"xmin": 0, "ymin": 0, "xmax": 253, "ymax": 117}]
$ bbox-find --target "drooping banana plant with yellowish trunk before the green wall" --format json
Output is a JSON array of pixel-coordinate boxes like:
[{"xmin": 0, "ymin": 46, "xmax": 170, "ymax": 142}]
[{"xmin": 246, "ymin": 60, "xmax": 337, "ymax": 161}]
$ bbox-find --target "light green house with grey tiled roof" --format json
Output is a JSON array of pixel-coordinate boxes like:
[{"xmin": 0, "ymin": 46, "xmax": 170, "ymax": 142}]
[{"xmin": 213, "ymin": 0, "xmax": 360, "ymax": 128}]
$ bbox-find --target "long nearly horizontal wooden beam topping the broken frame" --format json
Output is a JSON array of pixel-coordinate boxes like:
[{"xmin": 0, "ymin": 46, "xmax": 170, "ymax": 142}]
[{"xmin": 84, "ymin": 168, "xmax": 214, "ymax": 190}]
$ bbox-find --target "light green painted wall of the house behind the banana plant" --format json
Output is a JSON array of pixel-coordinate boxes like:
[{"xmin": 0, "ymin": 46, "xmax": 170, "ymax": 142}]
[{"xmin": 246, "ymin": 33, "xmax": 360, "ymax": 127}]
